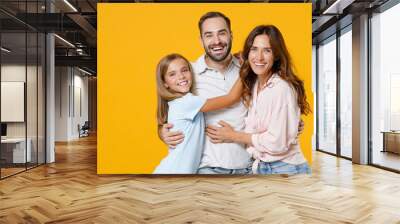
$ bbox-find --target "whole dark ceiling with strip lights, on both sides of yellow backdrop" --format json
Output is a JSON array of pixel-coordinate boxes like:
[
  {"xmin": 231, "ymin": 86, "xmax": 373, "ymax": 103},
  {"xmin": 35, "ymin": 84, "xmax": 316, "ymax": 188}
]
[{"xmin": 0, "ymin": 0, "xmax": 394, "ymax": 75}]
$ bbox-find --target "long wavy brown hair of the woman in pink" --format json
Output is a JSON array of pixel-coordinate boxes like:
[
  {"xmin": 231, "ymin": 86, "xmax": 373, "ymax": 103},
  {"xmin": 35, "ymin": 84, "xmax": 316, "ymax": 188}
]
[{"xmin": 240, "ymin": 25, "xmax": 311, "ymax": 115}]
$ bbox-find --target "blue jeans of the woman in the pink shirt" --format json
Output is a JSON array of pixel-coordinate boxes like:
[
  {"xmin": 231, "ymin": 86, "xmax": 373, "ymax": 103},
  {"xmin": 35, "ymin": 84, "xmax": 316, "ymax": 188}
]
[{"xmin": 257, "ymin": 161, "xmax": 311, "ymax": 175}]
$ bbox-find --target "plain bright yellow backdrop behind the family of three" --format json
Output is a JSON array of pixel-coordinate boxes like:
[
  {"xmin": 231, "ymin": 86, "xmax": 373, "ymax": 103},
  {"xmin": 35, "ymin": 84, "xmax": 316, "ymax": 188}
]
[{"xmin": 97, "ymin": 3, "xmax": 313, "ymax": 174}]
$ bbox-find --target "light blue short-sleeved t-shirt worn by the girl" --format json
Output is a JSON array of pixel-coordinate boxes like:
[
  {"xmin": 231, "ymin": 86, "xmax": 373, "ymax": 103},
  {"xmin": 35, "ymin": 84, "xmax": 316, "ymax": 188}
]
[{"xmin": 154, "ymin": 93, "xmax": 206, "ymax": 174}]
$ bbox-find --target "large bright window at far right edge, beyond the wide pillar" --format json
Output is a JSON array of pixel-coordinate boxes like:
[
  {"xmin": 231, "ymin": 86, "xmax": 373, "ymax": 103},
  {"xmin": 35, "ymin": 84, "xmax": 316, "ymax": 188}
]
[{"xmin": 370, "ymin": 1, "xmax": 400, "ymax": 170}]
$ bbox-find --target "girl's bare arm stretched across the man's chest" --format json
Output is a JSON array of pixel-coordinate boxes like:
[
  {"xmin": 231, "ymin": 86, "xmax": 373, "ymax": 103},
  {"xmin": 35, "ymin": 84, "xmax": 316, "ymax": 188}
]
[{"xmin": 200, "ymin": 78, "xmax": 243, "ymax": 112}]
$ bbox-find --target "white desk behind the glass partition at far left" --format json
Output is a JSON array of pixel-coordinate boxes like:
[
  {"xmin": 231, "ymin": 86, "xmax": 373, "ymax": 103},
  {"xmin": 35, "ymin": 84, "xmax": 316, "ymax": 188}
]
[{"xmin": 1, "ymin": 138, "xmax": 32, "ymax": 163}]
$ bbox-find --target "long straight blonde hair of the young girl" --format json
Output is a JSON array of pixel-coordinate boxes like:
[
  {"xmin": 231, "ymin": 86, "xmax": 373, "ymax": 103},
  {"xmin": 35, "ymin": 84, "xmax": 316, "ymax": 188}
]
[{"xmin": 156, "ymin": 53, "xmax": 194, "ymax": 125}]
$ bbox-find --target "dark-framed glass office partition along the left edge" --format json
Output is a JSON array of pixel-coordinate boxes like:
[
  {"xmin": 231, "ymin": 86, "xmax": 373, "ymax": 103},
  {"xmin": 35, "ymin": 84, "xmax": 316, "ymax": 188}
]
[{"xmin": 0, "ymin": 1, "xmax": 46, "ymax": 179}]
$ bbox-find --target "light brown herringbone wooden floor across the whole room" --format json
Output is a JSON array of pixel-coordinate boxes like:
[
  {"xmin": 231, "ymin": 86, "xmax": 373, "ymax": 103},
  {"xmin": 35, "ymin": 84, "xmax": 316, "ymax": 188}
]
[{"xmin": 0, "ymin": 134, "xmax": 400, "ymax": 224}]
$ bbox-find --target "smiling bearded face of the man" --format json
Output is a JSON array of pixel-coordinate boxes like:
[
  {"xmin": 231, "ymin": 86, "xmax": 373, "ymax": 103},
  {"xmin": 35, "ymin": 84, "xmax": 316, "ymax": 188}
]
[{"xmin": 201, "ymin": 17, "xmax": 232, "ymax": 62}]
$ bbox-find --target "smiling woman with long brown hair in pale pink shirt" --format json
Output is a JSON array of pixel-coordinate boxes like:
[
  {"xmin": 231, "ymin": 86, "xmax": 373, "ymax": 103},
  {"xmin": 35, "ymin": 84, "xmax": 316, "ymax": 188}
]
[{"xmin": 207, "ymin": 25, "xmax": 311, "ymax": 174}]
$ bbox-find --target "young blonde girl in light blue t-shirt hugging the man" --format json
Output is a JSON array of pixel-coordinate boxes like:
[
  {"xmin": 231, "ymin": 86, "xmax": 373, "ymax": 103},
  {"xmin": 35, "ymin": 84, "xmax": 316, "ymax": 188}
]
[{"xmin": 154, "ymin": 54, "xmax": 242, "ymax": 174}]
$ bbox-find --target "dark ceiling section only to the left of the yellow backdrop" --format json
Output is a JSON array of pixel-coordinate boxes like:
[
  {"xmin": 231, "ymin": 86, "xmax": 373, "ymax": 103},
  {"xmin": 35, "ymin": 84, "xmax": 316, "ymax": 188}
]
[{"xmin": 0, "ymin": 0, "xmax": 97, "ymax": 73}]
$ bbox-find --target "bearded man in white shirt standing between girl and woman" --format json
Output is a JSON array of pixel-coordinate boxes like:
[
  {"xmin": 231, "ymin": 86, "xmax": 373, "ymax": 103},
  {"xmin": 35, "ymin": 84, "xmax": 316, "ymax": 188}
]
[{"xmin": 160, "ymin": 12, "xmax": 250, "ymax": 174}]
